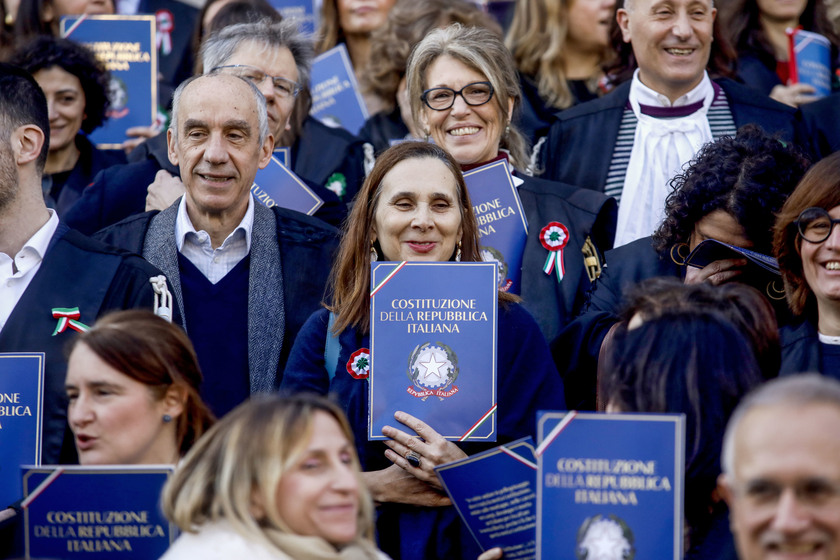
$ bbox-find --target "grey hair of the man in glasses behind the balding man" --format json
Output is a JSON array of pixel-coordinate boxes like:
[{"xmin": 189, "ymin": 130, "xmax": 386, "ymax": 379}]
[{"xmin": 199, "ymin": 18, "xmax": 315, "ymax": 88}]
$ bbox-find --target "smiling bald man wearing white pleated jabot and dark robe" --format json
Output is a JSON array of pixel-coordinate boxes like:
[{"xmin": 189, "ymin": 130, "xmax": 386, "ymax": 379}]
[{"xmin": 541, "ymin": 0, "xmax": 794, "ymax": 246}]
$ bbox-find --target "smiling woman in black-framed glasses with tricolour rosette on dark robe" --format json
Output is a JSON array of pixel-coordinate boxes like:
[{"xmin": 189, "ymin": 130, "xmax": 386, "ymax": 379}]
[{"xmin": 406, "ymin": 23, "xmax": 616, "ymax": 340}]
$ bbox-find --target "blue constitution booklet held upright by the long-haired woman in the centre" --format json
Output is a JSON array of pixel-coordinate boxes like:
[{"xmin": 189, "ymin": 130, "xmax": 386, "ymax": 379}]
[{"xmin": 368, "ymin": 262, "xmax": 498, "ymax": 441}]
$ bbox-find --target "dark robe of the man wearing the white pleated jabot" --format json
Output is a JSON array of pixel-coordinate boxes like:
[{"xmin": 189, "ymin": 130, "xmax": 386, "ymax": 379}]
[{"xmin": 539, "ymin": 79, "xmax": 794, "ymax": 192}]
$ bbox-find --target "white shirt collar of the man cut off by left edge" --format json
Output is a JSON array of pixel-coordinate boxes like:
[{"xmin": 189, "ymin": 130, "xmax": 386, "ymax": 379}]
[{"xmin": 0, "ymin": 209, "xmax": 58, "ymax": 332}]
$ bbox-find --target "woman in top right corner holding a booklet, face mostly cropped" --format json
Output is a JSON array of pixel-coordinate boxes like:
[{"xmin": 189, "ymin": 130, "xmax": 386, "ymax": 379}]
[{"xmin": 718, "ymin": 0, "xmax": 840, "ymax": 107}]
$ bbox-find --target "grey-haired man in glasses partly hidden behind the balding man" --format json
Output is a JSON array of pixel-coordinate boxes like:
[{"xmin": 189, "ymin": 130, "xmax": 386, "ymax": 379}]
[{"xmin": 65, "ymin": 20, "xmax": 365, "ymax": 234}]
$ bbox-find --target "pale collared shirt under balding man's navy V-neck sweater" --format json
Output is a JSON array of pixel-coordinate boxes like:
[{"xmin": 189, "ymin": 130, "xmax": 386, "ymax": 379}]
[{"xmin": 175, "ymin": 195, "xmax": 254, "ymax": 284}]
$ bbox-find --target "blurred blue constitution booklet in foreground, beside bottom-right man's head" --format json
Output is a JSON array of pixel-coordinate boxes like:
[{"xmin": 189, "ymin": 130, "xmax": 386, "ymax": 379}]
[{"xmin": 537, "ymin": 412, "xmax": 685, "ymax": 560}]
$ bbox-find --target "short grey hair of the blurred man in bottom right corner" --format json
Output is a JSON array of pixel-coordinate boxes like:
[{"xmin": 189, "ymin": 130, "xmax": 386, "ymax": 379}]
[{"xmin": 721, "ymin": 373, "xmax": 840, "ymax": 476}]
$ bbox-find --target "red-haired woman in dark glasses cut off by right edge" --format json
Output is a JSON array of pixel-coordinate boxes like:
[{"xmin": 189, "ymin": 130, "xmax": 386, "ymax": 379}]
[{"xmin": 774, "ymin": 153, "xmax": 840, "ymax": 377}]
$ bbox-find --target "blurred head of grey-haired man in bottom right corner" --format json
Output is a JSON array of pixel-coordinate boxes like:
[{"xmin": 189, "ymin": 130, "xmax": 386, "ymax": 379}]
[{"xmin": 718, "ymin": 374, "xmax": 840, "ymax": 560}]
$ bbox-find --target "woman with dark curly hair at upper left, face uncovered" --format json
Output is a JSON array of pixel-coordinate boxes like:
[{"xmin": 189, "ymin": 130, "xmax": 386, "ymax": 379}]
[{"xmin": 9, "ymin": 35, "xmax": 125, "ymax": 216}]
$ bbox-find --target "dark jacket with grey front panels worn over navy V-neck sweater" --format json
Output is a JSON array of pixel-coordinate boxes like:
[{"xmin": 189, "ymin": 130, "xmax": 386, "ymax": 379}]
[{"xmin": 97, "ymin": 200, "xmax": 338, "ymax": 393}]
